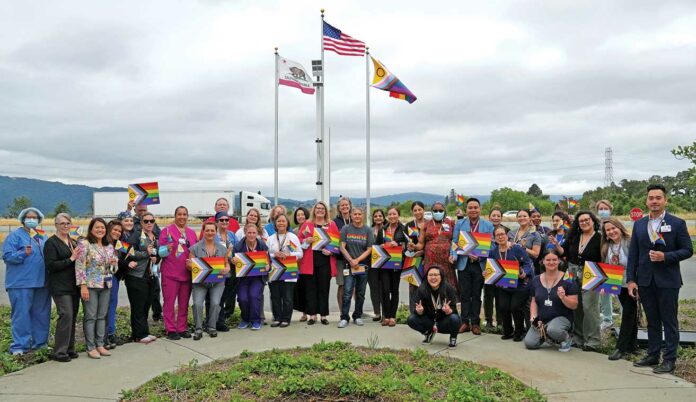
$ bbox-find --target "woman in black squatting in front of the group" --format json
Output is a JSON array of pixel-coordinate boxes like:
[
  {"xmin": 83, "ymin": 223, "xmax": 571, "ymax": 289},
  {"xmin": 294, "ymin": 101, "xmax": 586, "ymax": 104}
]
[{"xmin": 408, "ymin": 265, "xmax": 462, "ymax": 348}]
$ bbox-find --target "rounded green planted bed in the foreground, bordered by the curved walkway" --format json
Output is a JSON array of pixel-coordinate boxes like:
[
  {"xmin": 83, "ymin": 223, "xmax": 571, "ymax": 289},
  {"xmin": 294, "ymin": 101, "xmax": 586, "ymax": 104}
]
[{"xmin": 123, "ymin": 342, "xmax": 545, "ymax": 401}]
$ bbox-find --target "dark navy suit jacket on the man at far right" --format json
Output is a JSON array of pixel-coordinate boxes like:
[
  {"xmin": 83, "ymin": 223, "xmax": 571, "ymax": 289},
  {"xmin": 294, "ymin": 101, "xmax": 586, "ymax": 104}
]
[{"xmin": 626, "ymin": 213, "xmax": 694, "ymax": 288}]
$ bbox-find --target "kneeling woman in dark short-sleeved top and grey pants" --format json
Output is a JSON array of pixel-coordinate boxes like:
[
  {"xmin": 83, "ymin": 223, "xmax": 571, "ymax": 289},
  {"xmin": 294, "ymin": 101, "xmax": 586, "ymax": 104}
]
[{"xmin": 524, "ymin": 250, "xmax": 578, "ymax": 352}]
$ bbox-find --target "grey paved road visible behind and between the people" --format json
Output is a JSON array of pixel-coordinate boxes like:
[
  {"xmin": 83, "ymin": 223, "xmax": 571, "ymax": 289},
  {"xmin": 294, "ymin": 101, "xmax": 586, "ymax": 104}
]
[{"xmin": 0, "ymin": 257, "xmax": 696, "ymax": 308}]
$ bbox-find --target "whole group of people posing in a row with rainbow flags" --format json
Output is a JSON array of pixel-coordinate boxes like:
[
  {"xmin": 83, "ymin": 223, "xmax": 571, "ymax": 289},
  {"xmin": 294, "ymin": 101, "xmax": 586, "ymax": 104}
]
[{"xmin": 3, "ymin": 185, "xmax": 693, "ymax": 373}]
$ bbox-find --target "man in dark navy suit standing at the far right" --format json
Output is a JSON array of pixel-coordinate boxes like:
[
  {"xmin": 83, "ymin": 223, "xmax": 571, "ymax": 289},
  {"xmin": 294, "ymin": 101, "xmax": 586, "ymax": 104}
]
[{"xmin": 626, "ymin": 184, "xmax": 694, "ymax": 374}]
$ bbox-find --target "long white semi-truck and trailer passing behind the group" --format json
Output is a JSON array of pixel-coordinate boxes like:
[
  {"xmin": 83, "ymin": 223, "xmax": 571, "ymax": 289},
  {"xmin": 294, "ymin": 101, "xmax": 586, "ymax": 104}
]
[{"xmin": 93, "ymin": 190, "xmax": 271, "ymax": 222}]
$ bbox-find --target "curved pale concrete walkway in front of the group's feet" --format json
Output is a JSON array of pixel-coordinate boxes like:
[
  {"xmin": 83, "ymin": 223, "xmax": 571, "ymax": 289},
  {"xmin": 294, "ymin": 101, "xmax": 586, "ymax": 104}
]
[{"xmin": 0, "ymin": 317, "xmax": 696, "ymax": 402}]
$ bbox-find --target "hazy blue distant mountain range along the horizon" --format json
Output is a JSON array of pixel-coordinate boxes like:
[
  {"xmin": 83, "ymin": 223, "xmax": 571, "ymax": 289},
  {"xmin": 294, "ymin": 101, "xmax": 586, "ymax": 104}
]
[{"xmin": 0, "ymin": 176, "xmax": 576, "ymax": 215}]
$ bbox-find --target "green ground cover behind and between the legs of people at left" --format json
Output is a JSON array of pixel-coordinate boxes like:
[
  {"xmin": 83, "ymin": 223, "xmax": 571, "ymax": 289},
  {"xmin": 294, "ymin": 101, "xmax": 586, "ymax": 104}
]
[{"xmin": 0, "ymin": 306, "xmax": 240, "ymax": 375}]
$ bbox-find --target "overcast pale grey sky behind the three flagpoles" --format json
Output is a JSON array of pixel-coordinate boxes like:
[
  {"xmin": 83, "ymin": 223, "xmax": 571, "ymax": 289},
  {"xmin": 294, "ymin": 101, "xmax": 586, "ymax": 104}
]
[{"xmin": 0, "ymin": 0, "xmax": 696, "ymax": 199}]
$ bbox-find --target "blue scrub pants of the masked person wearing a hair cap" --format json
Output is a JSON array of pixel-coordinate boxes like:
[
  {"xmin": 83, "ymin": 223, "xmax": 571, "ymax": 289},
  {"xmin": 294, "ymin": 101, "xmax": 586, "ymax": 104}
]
[{"xmin": 7, "ymin": 287, "xmax": 51, "ymax": 353}]
